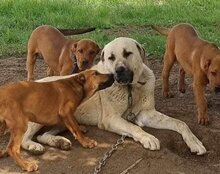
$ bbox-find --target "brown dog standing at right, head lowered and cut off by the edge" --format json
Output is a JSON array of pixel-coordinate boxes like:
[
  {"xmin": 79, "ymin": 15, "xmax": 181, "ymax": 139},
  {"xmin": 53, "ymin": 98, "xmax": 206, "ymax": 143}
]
[{"xmin": 153, "ymin": 24, "xmax": 220, "ymax": 124}]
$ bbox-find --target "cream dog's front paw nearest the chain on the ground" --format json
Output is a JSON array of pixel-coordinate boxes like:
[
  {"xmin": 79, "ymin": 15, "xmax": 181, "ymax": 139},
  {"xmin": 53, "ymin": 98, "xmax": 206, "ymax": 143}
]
[{"xmin": 140, "ymin": 135, "xmax": 160, "ymax": 150}]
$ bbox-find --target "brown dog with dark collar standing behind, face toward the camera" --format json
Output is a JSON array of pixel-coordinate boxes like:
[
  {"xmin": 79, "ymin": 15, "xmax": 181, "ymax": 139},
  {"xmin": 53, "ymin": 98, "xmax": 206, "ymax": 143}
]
[{"xmin": 26, "ymin": 25, "xmax": 100, "ymax": 81}]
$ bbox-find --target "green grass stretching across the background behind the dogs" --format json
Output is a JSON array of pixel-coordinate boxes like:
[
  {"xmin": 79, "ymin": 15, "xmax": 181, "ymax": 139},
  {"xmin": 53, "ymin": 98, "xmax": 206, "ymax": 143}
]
[{"xmin": 0, "ymin": 0, "xmax": 220, "ymax": 57}]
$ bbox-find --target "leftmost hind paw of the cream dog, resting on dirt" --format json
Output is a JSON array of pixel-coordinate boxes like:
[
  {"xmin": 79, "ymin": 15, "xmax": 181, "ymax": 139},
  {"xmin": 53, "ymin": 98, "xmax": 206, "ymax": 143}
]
[{"xmin": 22, "ymin": 141, "xmax": 45, "ymax": 155}]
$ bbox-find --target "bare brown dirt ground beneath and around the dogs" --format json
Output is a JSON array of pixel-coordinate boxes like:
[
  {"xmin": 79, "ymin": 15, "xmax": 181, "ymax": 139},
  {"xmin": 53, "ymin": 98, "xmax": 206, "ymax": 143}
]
[{"xmin": 0, "ymin": 58, "xmax": 220, "ymax": 174}]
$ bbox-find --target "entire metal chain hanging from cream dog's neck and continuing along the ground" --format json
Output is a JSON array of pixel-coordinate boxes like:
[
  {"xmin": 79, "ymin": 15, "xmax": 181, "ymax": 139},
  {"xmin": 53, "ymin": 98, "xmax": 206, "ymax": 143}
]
[{"xmin": 94, "ymin": 85, "xmax": 135, "ymax": 174}]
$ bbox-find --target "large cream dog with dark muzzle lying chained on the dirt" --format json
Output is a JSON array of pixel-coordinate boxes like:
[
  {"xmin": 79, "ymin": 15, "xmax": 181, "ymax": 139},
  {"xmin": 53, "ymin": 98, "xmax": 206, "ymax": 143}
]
[{"xmin": 22, "ymin": 37, "xmax": 206, "ymax": 155}]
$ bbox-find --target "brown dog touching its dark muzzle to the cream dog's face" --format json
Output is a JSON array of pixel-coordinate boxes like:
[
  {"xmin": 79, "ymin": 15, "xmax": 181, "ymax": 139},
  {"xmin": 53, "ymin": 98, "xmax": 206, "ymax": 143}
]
[{"xmin": 0, "ymin": 70, "xmax": 114, "ymax": 171}]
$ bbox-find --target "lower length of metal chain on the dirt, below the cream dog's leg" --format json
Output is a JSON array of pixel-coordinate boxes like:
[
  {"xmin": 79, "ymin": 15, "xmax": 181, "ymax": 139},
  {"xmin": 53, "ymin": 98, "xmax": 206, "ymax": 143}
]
[{"xmin": 94, "ymin": 135, "xmax": 126, "ymax": 174}]
